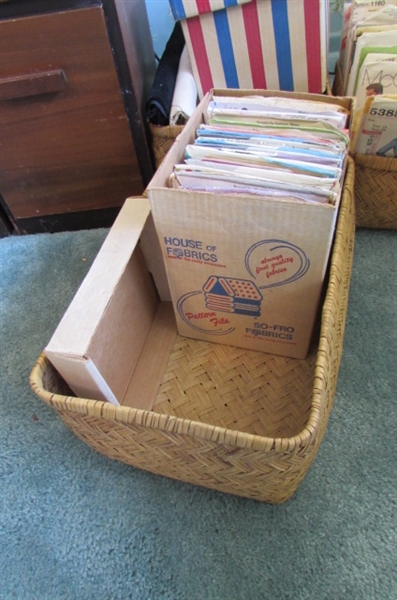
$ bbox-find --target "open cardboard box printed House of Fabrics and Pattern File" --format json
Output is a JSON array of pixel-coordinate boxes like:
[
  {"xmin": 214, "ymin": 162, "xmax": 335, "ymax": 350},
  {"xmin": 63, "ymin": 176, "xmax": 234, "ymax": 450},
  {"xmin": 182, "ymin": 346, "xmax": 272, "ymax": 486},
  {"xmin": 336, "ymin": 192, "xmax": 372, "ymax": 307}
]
[{"xmin": 147, "ymin": 90, "xmax": 351, "ymax": 358}]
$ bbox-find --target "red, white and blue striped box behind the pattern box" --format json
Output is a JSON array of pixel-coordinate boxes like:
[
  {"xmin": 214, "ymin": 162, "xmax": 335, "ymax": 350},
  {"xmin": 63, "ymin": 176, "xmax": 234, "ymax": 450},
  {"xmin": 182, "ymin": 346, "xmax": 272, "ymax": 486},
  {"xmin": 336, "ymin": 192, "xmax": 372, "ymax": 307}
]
[{"xmin": 170, "ymin": 0, "xmax": 329, "ymax": 98}]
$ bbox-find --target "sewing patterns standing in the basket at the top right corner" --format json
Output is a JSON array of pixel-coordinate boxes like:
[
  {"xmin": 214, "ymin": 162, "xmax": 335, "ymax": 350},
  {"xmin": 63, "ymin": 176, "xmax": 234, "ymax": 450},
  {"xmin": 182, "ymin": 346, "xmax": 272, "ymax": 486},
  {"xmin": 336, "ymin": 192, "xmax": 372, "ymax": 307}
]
[{"xmin": 340, "ymin": 0, "xmax": 397, "ymax": 158}]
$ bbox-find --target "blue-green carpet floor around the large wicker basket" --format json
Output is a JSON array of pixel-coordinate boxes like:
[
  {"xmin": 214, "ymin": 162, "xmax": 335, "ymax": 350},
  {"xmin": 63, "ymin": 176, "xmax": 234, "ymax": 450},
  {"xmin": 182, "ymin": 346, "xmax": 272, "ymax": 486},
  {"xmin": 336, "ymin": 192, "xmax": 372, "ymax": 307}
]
[{"xmin": 0, "ymin": 230, "xmax": 397, "ymax": 600}]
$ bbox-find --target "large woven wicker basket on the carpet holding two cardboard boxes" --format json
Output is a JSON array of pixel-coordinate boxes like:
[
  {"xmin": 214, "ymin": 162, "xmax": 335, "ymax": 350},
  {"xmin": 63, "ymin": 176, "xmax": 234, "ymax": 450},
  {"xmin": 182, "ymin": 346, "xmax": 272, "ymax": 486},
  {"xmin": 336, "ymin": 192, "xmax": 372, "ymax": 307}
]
[{"xmin": 30, "ymin": 159, "xmax": 355, "ymax": 503}]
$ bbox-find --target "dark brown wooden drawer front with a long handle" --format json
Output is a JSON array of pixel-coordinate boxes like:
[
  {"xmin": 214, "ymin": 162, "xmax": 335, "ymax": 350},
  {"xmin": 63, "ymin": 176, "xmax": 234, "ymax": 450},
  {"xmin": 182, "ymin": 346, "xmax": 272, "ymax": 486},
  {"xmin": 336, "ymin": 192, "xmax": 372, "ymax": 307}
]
[{"xmin": 0, "ymin": 7, "xmax": 144, "ymax": 219}]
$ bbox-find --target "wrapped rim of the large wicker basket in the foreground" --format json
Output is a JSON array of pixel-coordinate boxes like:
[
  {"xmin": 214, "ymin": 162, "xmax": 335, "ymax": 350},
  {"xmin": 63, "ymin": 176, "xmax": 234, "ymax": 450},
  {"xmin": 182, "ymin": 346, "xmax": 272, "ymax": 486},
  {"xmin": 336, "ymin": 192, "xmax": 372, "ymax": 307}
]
[{"xmin": 29, "ymin": 157, "xmax": 354, "ymax": 452}]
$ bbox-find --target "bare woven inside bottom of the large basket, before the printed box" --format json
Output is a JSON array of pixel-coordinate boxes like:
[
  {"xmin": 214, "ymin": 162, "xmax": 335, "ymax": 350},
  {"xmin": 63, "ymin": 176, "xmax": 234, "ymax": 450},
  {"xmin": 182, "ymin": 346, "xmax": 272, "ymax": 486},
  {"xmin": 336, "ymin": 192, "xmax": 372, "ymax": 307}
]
[{"xmin": 154, "ymin": 337, "xmax": 315, "ymax": 437}]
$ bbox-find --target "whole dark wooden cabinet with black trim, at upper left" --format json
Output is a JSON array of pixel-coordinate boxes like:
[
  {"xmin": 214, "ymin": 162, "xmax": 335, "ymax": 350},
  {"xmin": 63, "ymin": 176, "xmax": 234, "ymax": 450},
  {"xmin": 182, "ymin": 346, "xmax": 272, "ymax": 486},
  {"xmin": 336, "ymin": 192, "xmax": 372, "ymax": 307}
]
[{"xmin": 0, "ymin": 0, "xmax": 155, "ymax": 233}]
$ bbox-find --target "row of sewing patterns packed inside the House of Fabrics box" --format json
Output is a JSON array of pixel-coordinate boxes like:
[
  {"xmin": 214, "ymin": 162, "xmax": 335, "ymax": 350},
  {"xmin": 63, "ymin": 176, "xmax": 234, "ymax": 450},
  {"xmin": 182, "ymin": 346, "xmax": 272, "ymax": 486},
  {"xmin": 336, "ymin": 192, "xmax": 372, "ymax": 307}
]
[{"xmin": 171, "ymin": 95, "xmax": 349, "ymax": 204}]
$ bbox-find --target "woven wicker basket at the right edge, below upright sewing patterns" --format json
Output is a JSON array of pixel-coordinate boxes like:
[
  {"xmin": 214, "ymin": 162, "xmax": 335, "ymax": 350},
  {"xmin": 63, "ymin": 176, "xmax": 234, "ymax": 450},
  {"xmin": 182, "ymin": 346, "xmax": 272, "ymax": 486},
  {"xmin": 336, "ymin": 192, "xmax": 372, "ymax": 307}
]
[{"xmin": 333, "ymin": 63, "xmax": 397, "ymax": 229}]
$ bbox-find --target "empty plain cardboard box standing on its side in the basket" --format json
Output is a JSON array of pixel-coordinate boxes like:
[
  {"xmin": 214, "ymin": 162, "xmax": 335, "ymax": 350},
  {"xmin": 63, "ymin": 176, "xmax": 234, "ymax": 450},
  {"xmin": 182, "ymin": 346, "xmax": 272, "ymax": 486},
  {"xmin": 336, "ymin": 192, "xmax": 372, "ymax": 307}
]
[{"xmin": 45, "ymin": 198, "xmax": 159, "ymax": 404}]
